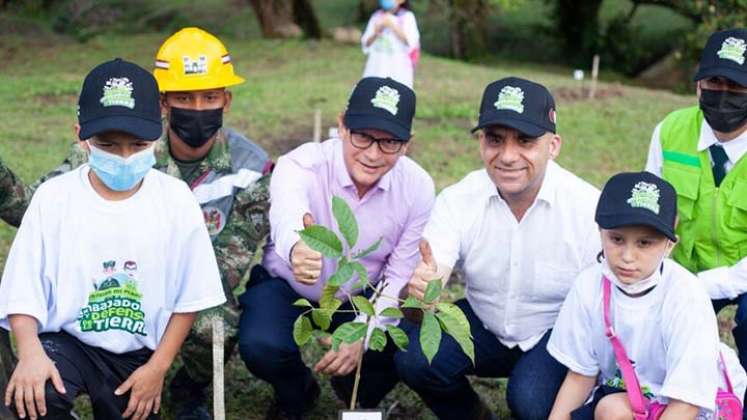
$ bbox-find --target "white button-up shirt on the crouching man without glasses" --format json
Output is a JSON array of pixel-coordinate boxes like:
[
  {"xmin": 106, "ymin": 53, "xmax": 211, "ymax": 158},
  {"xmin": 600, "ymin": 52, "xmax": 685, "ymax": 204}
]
[{"xmin": 423, "ymin": 161, "xmax": 602, "ymax": 351}]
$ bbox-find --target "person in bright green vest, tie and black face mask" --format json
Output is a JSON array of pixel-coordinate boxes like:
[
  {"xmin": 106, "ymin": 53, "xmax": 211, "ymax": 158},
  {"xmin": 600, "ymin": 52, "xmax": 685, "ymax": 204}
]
[{"xmin": 646, "ymin": 29, "xmax": 747, "ymax": 414}]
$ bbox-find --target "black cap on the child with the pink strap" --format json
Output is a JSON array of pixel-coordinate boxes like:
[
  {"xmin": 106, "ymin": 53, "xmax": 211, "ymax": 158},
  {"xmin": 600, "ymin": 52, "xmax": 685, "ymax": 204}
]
[{"xmin": 594, "ymin": 172, "xmax": 677, "ymax": 242}]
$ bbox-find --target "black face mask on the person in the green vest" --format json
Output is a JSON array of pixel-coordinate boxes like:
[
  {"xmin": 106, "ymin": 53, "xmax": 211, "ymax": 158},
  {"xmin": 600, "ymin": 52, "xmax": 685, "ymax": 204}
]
[{"xmin": 700, "ymin": 89, "xmax": 747, "ymax": 133}]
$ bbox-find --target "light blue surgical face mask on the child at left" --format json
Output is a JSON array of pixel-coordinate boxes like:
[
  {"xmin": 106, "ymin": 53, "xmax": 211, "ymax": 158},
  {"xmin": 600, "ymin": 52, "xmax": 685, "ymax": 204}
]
[{"xmin": 88, "ymin": 142, "xmax": 156, "ymax": 191}]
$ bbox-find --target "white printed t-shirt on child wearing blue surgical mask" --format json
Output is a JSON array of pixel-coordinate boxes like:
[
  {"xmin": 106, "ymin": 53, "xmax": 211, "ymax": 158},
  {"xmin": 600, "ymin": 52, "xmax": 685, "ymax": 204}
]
[{"xmin": 0, "ymin": 165, "xmax": 226, "ymax": 354}]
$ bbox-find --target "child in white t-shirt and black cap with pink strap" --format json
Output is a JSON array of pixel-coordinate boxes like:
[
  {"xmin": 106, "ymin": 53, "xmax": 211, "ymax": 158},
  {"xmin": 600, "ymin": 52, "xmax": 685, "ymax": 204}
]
[{"xmin": 547, "ymin": 172, "xmax": 746, "ymax": 420}]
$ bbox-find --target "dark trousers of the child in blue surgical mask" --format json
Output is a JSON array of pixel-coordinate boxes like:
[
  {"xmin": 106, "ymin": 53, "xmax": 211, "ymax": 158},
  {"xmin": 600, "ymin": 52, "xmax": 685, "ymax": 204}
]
[{"xmin": 13, "ymin": 332, "xmax": 158, "ymax": 420}]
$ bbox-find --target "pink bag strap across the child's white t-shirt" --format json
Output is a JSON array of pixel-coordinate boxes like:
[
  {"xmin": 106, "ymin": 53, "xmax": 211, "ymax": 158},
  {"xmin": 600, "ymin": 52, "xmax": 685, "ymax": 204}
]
[{"xmin": 602, "ymin": 276, "xmax": 648, "ymax": 420}]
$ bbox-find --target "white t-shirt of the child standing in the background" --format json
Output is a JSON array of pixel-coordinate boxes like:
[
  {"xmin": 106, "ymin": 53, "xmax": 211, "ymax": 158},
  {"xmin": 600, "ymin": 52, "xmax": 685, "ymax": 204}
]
[{"xmin": 361, "ymin": 9, "xmax": 420, "ymax": 89}]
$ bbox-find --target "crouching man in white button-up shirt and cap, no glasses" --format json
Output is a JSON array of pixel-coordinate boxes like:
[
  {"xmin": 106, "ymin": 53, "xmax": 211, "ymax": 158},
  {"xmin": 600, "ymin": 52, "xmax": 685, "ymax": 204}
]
[{"xmin": 395, "ymin": 77, "xmax": 601, "ymax": 419}]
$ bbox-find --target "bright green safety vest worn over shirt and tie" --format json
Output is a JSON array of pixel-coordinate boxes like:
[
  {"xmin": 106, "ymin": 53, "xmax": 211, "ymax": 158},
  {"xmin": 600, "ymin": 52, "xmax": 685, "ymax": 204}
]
[{"xmin": 660, "ymin": 106, "xmax": 747, "ymax": 273}]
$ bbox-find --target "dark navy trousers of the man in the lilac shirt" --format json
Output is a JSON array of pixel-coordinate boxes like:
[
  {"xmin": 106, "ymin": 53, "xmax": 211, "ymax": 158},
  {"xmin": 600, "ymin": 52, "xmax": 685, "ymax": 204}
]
[{"xmin": 239, "ymin": 265, "xmax": 398, "ymax": 414}]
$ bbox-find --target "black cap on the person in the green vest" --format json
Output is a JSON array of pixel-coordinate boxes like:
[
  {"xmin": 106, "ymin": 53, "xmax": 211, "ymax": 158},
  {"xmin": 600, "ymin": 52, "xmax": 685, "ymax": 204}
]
[{"xmin": 693, "ymin": 29, "xmax": 747, "ymax": 86}]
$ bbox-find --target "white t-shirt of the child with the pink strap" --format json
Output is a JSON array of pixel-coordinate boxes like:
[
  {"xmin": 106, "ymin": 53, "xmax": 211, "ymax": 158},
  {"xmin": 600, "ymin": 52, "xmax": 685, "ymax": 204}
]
[{"xmin": 547, "ymin": 259, "xmax": 747, "ymax": 418}]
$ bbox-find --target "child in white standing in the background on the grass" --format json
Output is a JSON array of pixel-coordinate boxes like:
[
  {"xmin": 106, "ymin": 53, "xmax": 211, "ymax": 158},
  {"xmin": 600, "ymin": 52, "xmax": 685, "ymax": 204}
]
[{"xmin": 361, "ymin": 0, "xmax": 420, "ymax": 89}]
